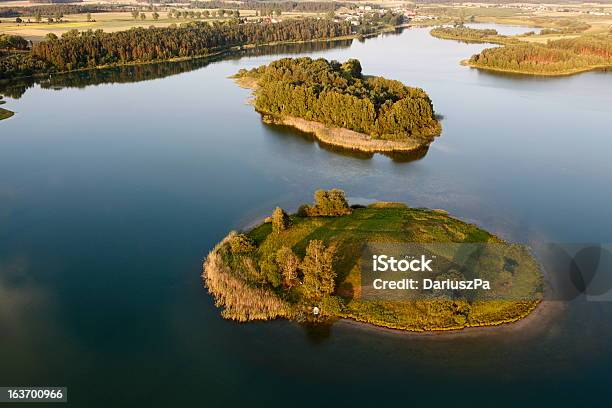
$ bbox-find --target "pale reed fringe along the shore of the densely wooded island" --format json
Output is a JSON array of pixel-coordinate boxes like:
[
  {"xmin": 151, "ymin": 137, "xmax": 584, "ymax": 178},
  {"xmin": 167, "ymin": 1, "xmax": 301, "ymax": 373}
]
[{"xmin": 230, "ymin": 76, "xmax": 441, "ymax": 153}]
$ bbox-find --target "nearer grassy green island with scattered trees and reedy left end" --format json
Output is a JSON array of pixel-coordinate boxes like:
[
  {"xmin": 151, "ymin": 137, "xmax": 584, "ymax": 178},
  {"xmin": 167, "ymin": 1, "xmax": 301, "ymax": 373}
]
[{"xmin": 202, "ymin": 190, "xmax": 543, "ymax": 332}]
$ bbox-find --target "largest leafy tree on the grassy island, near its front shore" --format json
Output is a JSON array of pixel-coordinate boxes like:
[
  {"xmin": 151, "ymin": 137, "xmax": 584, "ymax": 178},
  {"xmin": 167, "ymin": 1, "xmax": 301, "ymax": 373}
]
[{"xmin": 300, "ymin": 239, "xmax": 336, "ymax": 300}]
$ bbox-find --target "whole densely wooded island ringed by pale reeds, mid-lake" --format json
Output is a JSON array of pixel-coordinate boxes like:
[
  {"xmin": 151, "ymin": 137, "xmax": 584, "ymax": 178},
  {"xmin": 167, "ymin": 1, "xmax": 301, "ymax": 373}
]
[{"xmin": 235, "ymin": 57, "xmax": 441, "ymax": 152}]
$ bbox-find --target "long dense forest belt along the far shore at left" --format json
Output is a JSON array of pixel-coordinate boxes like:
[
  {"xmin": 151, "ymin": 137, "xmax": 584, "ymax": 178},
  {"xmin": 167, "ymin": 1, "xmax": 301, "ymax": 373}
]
[{"xmin": 0, "ymin": 19, "xmax": 352, "ymax": 79}]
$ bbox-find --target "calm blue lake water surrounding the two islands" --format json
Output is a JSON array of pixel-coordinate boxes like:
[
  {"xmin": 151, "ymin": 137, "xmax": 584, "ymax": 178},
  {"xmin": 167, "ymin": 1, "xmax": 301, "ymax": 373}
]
[{"xmin": 0, "ymin": 27, "xmax": 612, "ymax": 407}]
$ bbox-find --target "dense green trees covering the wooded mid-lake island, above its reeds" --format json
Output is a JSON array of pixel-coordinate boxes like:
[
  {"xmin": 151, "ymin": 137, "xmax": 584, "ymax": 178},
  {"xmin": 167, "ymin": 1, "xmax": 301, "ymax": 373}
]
[{"xmin": 238, "ymin": 58, "xmax": 440, "ymax": 139}]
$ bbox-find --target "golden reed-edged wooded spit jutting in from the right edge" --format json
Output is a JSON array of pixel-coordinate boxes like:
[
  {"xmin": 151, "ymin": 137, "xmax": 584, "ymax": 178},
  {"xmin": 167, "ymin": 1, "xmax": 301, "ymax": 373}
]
[{"xmin": 470, "ymin": 35, "xmax": 612, "ymax": 74}]
